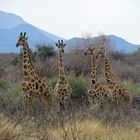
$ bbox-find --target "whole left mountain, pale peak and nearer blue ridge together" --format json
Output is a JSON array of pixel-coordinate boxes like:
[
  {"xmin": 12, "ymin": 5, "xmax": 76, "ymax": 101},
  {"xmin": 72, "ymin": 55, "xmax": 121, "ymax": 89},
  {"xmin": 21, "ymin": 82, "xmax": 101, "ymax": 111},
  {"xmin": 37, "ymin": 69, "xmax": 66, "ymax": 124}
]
[{"xmin": 0, "ymin": 11, "xmax": 62, "ymax": 53}]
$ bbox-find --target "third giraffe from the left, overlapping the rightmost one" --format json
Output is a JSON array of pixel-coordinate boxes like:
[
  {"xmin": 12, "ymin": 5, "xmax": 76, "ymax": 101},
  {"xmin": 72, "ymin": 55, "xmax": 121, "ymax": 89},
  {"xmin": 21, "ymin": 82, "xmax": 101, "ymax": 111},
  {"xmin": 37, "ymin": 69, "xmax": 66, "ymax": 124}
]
[{"xmin": 84, "ymin": 44, "xmax": 112, "ymax": 107}]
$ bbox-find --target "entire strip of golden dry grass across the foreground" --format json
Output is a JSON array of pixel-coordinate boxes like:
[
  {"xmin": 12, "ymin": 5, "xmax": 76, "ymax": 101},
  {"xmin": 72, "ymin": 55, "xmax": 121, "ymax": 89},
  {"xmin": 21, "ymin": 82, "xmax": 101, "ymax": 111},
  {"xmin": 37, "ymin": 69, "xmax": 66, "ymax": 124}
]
[{"xmin": 0, "ymin": 107, "xmax": 140, "ymax": 140}]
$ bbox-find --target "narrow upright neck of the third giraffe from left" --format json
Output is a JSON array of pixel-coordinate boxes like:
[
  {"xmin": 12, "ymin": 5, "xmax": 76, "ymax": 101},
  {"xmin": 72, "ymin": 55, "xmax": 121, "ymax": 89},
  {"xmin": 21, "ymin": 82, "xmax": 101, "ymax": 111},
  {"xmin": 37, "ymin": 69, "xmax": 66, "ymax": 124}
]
[{"xmin": 91, "ymin": 59, "xmax": 98, "ymax": 85}]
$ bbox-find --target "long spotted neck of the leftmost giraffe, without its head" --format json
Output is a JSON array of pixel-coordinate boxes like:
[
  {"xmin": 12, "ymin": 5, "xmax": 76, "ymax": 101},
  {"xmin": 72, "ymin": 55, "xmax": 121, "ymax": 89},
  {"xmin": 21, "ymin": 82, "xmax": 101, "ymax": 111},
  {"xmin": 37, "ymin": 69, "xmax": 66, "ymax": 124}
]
[{"xmin": 23, "ymin": 42, "xmax": 35, "ymax": 77}]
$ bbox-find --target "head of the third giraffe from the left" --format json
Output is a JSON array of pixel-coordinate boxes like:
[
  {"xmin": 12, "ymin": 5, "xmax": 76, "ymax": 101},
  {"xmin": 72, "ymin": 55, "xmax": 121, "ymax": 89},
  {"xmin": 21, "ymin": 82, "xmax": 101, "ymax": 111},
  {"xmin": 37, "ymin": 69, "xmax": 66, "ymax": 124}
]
[{"xmin": 84, "ymin": 44, "xmax": 96, "ymax": 58}]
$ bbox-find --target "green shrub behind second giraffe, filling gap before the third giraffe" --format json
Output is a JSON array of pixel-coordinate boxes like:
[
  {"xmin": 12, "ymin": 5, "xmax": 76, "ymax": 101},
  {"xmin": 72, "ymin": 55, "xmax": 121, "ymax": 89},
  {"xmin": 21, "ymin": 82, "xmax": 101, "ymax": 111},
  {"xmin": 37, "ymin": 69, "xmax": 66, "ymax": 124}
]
[{"xmin": 50, "ymin": 75, "xmax": 87, "ymax": 103}]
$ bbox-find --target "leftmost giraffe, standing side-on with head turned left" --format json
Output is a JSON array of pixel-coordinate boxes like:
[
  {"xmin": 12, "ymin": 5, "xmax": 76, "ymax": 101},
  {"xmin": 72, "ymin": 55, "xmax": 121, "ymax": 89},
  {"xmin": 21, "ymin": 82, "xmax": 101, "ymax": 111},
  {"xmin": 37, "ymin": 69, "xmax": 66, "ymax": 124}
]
[{"xmin": 16, "ymin": 32, "xmax": 53, "ymax": 112}]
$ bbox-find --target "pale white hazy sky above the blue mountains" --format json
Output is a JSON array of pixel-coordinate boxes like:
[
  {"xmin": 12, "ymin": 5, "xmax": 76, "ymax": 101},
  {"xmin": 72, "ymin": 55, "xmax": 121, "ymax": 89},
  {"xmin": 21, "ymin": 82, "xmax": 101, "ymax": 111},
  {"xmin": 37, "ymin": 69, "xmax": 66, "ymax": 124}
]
[{"xmin": 0, "ymin": 0, "xmax": 140, "ymax": 44}]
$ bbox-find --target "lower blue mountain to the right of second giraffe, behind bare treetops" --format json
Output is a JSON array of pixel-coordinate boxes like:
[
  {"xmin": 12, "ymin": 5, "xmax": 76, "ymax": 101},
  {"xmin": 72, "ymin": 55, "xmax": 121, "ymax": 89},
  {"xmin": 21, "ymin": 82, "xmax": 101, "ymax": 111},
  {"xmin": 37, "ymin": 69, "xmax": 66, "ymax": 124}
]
[{"xmin": 66, "ymin": 35, "xmax": 140, "ymax": 53}]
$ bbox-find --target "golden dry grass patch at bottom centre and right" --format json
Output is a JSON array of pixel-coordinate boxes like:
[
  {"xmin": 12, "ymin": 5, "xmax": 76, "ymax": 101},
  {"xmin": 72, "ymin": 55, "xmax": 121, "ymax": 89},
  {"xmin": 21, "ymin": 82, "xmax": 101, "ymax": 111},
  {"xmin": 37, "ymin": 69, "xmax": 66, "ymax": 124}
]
[{"xmin": 48, "ymin": 120, "xmax": 140, "ymax": 140}]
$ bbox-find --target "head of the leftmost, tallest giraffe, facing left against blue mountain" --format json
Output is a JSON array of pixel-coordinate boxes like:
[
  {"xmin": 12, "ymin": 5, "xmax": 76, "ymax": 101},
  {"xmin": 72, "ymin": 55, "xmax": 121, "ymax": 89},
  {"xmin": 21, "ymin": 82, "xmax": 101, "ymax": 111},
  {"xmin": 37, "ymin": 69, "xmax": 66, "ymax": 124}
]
[{"xmin": 16, "ymin": 32, "xmax": 28, "ymax": 47}]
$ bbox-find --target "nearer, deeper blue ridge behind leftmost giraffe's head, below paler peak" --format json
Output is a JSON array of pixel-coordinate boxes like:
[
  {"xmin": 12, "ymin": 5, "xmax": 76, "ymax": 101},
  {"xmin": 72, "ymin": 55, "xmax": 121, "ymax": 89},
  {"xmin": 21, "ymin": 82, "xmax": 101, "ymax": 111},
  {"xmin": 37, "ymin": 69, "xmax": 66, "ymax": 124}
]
[{"xmin": 0, "ymin": 24, "xmax": 54, "ymax": 52}]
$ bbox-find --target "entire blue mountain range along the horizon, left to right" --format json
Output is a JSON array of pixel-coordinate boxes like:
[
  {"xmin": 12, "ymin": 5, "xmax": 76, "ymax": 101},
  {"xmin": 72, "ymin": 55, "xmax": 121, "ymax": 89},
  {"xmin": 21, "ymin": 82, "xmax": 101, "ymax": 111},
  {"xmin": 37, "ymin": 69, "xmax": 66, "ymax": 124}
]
[{"xmin": 0, "ymin": 11, "xmax": 140, "ymax": 53}]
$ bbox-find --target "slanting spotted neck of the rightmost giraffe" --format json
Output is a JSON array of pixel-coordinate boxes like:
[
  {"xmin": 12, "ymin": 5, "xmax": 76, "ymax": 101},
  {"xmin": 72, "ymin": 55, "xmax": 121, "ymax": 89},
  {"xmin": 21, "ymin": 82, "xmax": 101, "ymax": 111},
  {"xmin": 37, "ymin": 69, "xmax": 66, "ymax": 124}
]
[{"xmin": 104, "ymin": 56, "xmax": 116, "ymax": 85}]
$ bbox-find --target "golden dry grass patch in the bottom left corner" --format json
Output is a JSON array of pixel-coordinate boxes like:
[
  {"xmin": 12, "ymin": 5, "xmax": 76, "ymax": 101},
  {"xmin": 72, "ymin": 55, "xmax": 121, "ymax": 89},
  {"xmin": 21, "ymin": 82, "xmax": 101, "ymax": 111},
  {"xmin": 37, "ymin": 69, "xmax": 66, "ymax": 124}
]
[{"xmin": 0, "ymin": 113, "xmax": 38, "ymax": 140}]
